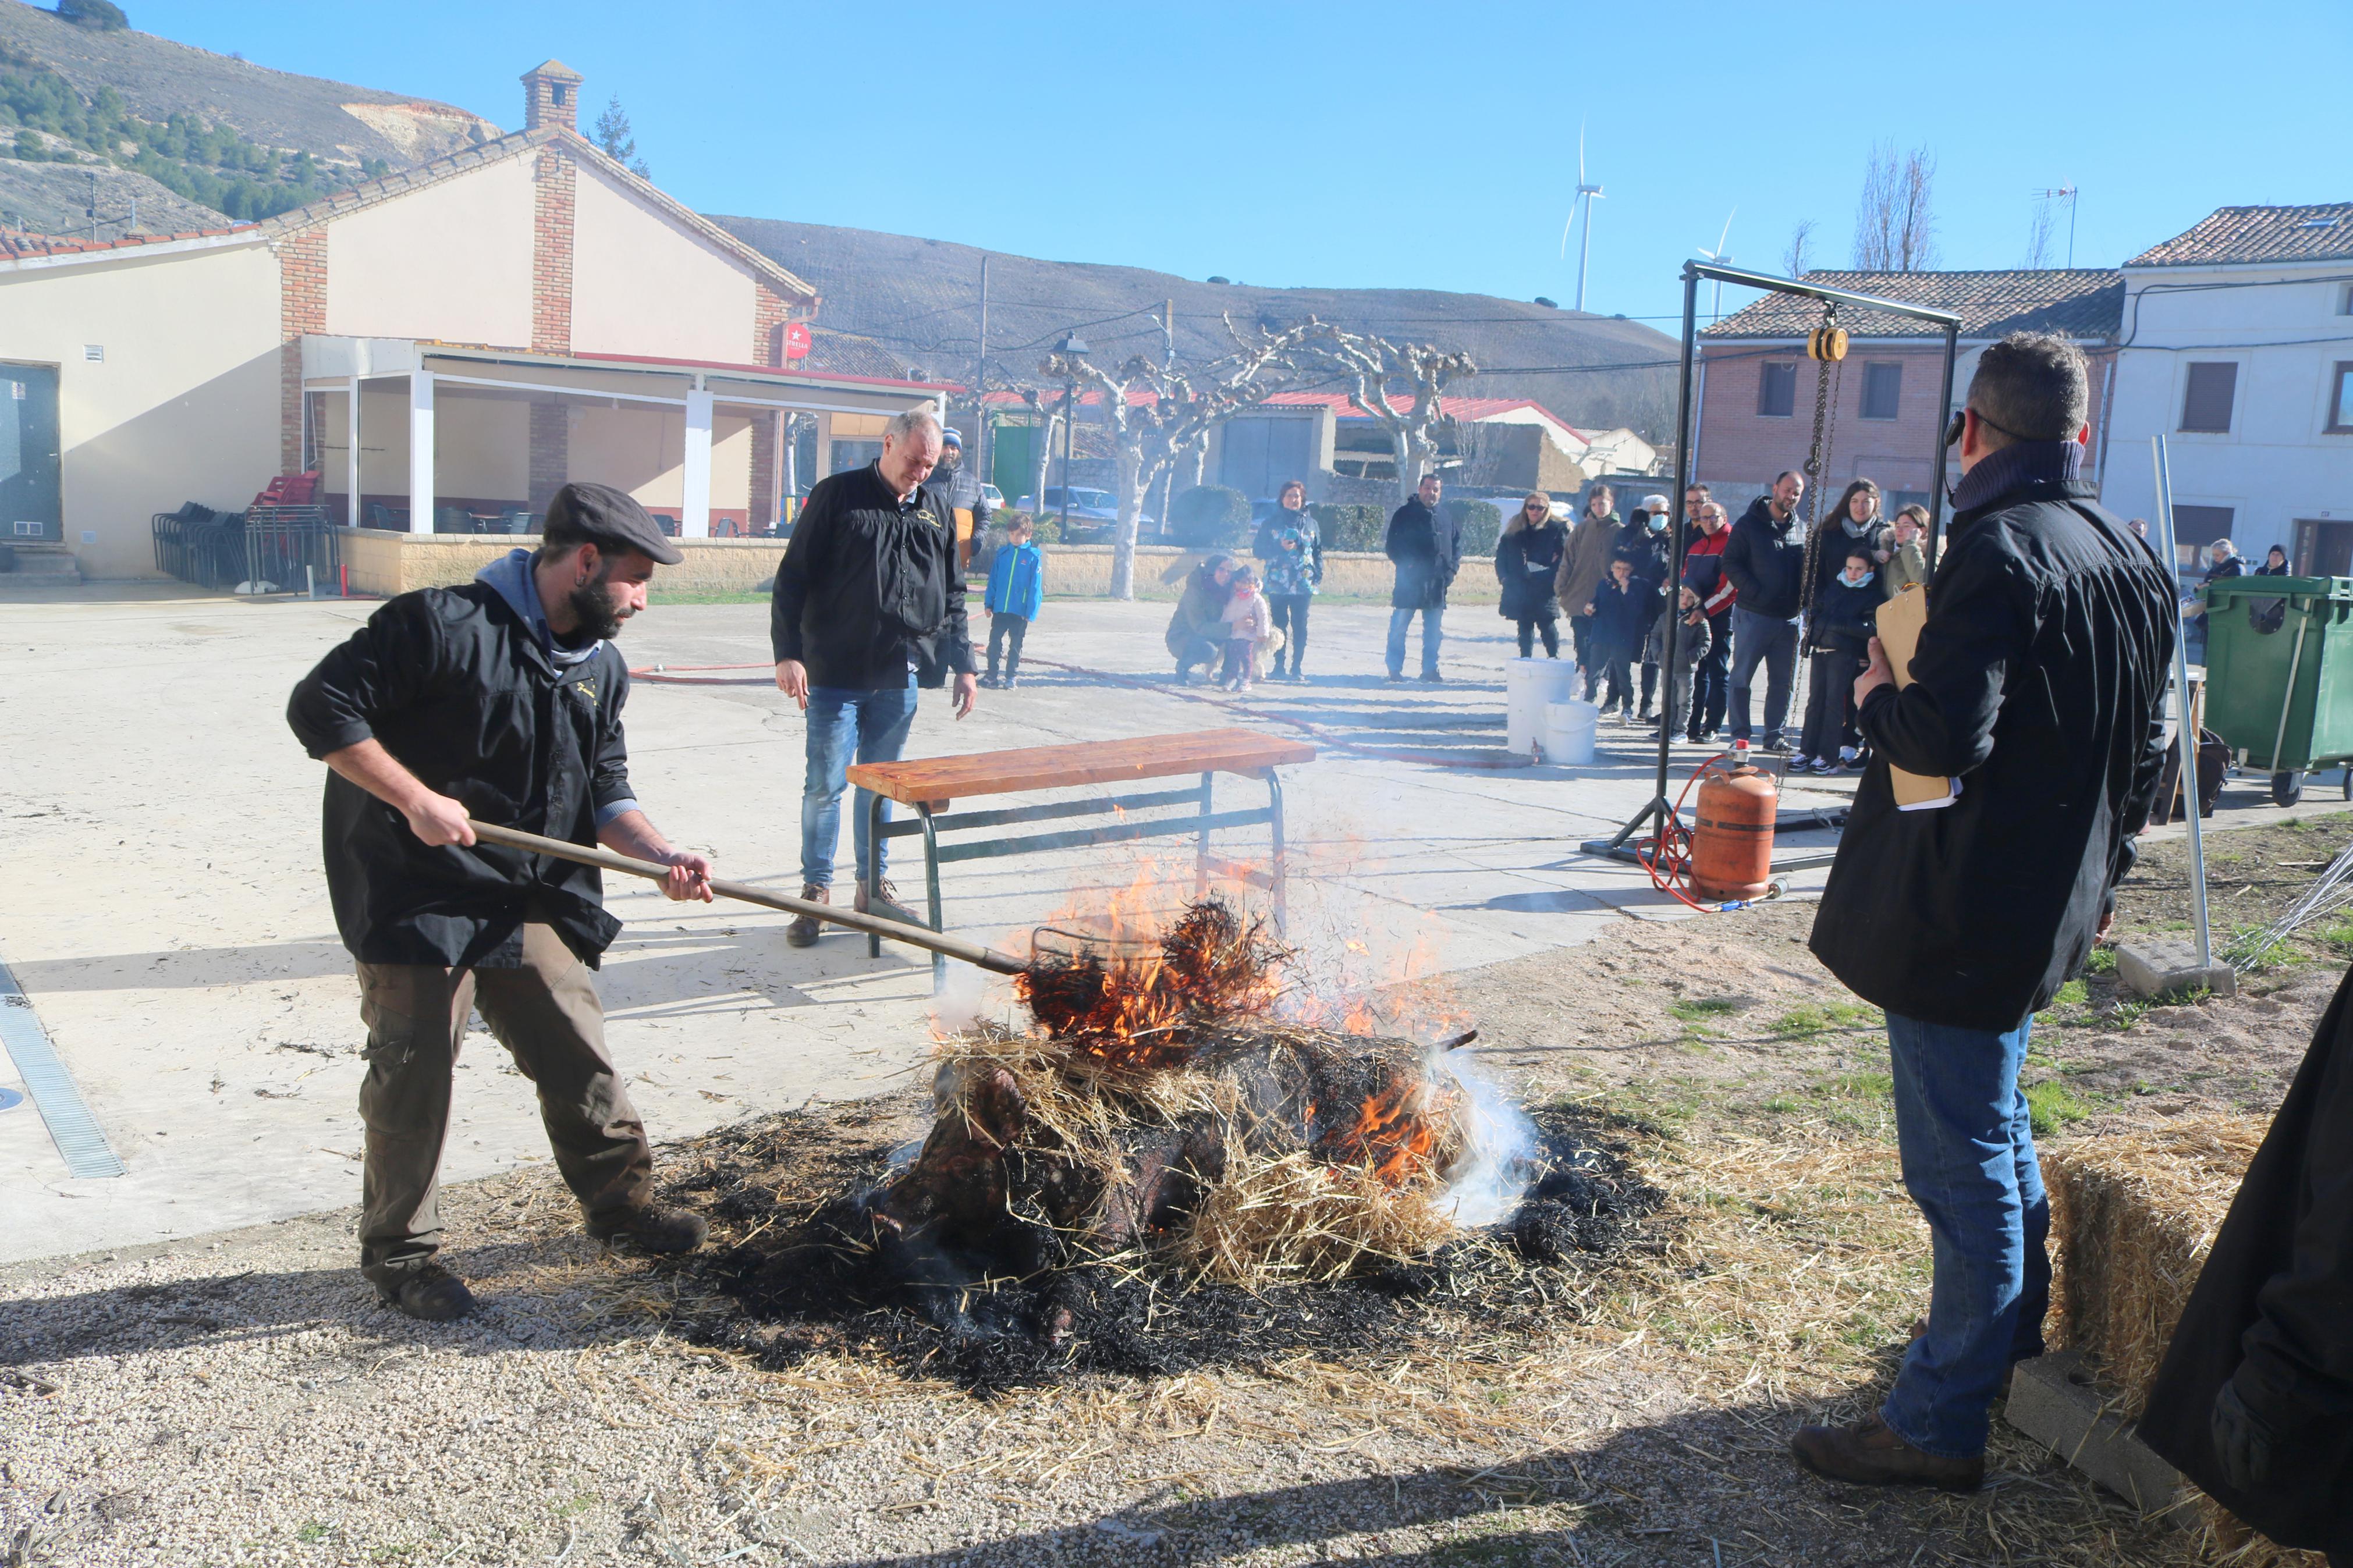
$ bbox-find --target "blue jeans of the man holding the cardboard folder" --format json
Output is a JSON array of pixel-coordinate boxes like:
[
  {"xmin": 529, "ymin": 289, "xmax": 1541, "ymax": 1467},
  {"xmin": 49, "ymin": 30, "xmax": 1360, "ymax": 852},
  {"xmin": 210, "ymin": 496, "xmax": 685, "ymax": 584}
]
[{"xmin": 1880, "ymin": 1013, "xmax": 2052, "ymax": 1457}]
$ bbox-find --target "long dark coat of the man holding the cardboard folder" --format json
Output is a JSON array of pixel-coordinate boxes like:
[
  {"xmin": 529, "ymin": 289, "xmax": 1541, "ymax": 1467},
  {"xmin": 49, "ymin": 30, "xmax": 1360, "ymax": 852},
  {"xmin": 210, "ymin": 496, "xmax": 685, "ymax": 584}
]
[{"xmin": 1807, "ymin": 479, "xmax": 2174, "ymax": 1030}]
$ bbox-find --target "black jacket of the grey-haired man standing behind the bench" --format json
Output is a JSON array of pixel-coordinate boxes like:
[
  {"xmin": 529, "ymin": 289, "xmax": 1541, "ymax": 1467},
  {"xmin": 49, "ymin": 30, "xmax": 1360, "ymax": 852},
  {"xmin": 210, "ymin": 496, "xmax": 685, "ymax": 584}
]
[{"xmin": 767, "ymin": 463, "xmax": 977, "ymax": 691}]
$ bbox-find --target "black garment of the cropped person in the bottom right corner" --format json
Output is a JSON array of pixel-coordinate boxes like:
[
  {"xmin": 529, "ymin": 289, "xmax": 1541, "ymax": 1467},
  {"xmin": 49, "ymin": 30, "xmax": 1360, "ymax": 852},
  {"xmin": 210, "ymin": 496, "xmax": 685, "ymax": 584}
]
[{"xmin": 2139, "ymin": 973, "xmax": 2353, "ymax": 1561}]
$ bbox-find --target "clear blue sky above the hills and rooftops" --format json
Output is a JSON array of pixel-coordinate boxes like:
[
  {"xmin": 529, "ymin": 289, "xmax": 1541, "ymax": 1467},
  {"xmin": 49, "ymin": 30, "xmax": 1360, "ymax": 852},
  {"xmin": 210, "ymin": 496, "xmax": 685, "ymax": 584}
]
[{"xmin": 122, "ymin": 0, "xmax": 2353, "ymax": 326}]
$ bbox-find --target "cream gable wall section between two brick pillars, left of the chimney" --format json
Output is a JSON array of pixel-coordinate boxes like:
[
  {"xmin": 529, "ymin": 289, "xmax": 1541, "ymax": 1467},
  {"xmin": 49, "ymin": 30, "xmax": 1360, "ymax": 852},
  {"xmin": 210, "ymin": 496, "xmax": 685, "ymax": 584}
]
[{"xmin": 327, "ymin": 158, "xmax": 534, "ymax": 348}]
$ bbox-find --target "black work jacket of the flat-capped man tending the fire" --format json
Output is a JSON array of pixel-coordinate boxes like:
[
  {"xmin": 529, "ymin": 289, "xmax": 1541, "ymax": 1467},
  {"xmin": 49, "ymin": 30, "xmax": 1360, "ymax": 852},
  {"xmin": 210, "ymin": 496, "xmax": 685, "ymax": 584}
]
[{"xmin": 287, "ymin": 583, "xmax": 631, "ymax": 969}]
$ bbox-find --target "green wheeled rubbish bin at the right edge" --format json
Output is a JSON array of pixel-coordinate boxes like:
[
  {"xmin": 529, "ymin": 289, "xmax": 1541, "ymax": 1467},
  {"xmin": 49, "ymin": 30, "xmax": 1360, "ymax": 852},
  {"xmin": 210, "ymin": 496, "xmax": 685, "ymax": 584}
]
[{"xmin": 2200, "ymin": 576, "xmax": 2353, "ymax": 806}]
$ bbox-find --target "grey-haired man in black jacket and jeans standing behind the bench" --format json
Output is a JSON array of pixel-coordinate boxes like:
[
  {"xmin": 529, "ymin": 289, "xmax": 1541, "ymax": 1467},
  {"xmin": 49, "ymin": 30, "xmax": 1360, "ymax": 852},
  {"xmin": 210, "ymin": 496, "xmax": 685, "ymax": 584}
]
[{"xmin": 767, "ymin": 407, "xmax": 979, "ymax": 947}]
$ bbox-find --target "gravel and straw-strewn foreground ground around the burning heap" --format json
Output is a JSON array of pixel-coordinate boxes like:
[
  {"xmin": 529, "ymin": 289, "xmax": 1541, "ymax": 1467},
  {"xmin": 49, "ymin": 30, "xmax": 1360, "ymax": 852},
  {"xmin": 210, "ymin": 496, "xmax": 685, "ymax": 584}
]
[{"xmin": 0, "ymin": 825, "xmax": 2344, "ymax": 1568}]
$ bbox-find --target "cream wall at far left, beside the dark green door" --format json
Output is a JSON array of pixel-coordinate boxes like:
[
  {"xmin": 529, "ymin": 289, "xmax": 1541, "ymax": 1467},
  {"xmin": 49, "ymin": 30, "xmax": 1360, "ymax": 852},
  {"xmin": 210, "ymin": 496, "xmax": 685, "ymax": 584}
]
[{"xmin": 0, "ymin": 242, "xmax": 278, "ymax": 578}]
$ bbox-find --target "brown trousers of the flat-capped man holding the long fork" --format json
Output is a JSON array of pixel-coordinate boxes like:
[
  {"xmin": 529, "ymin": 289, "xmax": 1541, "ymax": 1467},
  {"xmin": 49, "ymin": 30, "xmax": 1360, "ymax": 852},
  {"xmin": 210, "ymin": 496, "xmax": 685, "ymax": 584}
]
[{"xmin": 358, "ymin": 924, "xmax": 654, "ymax": 1288}]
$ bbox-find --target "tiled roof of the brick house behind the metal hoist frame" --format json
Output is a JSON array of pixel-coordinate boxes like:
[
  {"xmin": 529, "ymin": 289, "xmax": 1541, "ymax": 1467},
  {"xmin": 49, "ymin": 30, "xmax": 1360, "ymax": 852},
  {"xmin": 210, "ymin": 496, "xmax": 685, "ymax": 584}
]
[{"xmin": 1701, "ymin": 268, "xmax": 2125, "ymax": 339}]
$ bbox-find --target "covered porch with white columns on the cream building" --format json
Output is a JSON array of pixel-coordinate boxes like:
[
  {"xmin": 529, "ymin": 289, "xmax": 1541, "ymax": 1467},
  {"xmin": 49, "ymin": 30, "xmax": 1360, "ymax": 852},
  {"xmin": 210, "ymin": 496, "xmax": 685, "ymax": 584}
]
[{"xmin": 301, "ymin": 334, "xmax": 955, "ymax": 538}]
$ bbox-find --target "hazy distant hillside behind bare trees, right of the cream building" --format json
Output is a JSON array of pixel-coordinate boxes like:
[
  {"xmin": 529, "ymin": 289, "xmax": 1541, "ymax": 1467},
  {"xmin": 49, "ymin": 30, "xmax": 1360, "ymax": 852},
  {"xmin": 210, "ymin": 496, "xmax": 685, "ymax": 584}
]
[{"xmin": 711, "ymin": 214, "xmax": 1676, "ymax": 430}]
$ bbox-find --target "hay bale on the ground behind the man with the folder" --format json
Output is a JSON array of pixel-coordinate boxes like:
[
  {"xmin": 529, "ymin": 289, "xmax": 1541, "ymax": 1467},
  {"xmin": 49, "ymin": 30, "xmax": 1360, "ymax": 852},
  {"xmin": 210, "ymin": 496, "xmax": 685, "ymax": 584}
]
[{"xmin": 2042, "ymin": 1117, "xmax": 2268, "ymax": 1420}]
